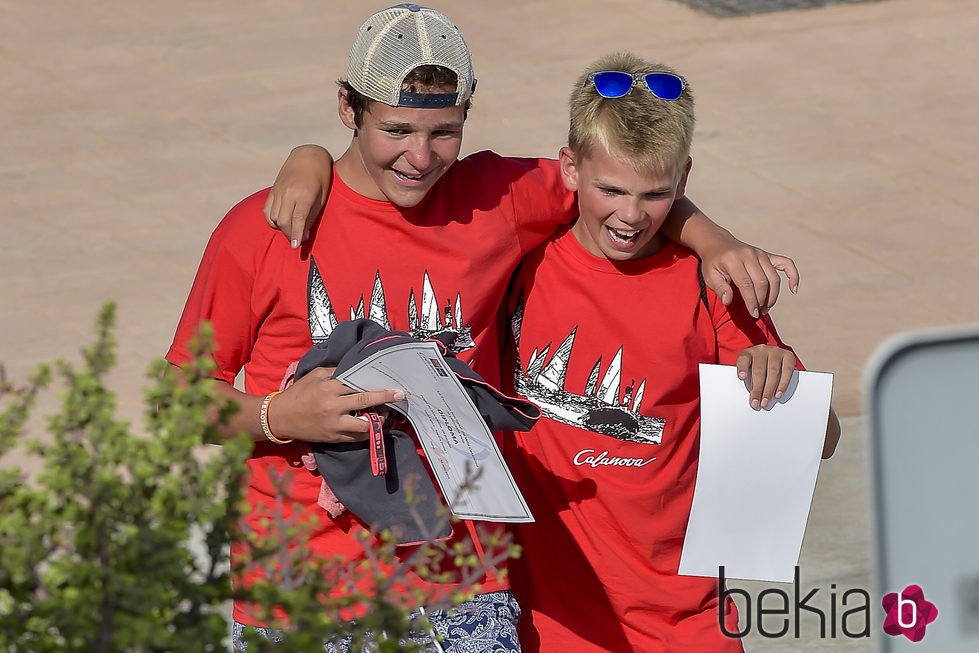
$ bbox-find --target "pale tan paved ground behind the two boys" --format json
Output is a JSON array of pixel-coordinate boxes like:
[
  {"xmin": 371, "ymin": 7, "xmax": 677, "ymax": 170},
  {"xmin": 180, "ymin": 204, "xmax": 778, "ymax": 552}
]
[{"xmin": 0, "ymin": 0, "xmax": 979, "ymax": 651}]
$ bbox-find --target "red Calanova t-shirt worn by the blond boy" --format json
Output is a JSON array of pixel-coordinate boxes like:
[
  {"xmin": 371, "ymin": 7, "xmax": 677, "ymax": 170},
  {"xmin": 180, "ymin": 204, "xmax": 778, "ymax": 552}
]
[{"xmin": 507, "ymin": 225, "xmax": 796, "ymax": 653}]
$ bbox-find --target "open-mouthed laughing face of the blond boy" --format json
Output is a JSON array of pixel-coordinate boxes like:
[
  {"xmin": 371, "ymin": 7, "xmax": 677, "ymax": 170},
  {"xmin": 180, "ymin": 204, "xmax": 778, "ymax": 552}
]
[{"xmin": 560, "ymin": 147, "xmax": 690, "ymax": 261}]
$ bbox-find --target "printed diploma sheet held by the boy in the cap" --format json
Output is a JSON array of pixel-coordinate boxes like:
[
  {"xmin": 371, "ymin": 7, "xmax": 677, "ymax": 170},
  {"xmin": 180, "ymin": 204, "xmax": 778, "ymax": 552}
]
[{"xmin": 337, "ymin": 342, "xmax": 534, "ymax": 522}]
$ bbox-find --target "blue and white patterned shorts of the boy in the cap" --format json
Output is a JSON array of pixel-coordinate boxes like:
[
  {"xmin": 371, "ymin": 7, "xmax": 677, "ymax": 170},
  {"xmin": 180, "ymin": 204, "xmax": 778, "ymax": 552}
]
[{"xmin": 232, "ymin": 590, "xmax": 520, "ymax": 653}]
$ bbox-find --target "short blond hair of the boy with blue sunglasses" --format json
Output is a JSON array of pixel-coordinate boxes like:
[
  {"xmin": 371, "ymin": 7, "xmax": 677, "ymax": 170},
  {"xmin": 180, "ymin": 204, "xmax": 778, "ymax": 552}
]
[{"xmin": 568, "ymin": 52, "xmax": 694, "ymax": 171}]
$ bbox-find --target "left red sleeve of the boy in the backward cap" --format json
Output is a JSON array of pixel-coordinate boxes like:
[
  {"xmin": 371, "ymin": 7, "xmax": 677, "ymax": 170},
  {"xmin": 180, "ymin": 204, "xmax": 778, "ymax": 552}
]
[{"xmin": 166, "ymin": 190, "xmax": 276, "ymax": 383}]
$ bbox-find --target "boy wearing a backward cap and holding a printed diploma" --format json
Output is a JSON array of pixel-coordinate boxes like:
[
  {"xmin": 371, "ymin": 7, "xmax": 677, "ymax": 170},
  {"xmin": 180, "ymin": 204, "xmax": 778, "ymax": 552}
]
[{"xmin": 167, "ymin": 5, "xmax": 791, "ymax": 653}]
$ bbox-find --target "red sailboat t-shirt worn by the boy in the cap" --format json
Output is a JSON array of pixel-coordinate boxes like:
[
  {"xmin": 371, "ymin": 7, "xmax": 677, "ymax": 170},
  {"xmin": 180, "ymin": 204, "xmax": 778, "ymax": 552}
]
[{"xmin": 166, "ymin": 152, "xmax": 574, "ymax": 625}]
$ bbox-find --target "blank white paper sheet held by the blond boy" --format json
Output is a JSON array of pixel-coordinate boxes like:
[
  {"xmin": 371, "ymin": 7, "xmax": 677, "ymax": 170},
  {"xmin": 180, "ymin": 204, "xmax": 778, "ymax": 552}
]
[{"xmin": 679, "ymin": 364, "xmax": 833, "ymax": 583}]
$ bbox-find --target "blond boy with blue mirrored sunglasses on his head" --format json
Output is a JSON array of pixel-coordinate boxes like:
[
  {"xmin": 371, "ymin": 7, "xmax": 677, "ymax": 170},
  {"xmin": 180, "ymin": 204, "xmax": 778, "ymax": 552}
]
[{"xmin": 507, "ymin": 53, "xmax": 839, "ymax": 653}]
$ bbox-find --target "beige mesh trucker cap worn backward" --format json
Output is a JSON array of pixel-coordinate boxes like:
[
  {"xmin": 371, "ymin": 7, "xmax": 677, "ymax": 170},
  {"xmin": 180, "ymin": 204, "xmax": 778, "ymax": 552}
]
[{"xmin": 347, "ymin": 3, "xmax": 476, "ymax": 108}]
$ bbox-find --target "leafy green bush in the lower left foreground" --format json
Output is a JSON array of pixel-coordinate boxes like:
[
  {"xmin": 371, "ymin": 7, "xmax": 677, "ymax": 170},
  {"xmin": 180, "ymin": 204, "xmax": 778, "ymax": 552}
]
[{"xmin": 0, "ymin": 304, "xmax": 515, "ymax": 653}]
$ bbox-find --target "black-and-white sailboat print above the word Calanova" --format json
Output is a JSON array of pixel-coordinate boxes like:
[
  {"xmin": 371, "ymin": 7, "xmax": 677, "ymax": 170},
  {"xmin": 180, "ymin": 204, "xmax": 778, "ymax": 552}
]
[{"xmin": 510, "ymin": 297, "xmax": 666, "ymax": 444}]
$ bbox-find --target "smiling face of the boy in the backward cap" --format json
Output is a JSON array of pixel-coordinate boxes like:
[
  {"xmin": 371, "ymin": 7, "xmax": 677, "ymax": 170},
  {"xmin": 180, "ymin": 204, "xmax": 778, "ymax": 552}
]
[{"xmin": 337, "ymin": 89, "xmax": 466, "ymax": 208}]
